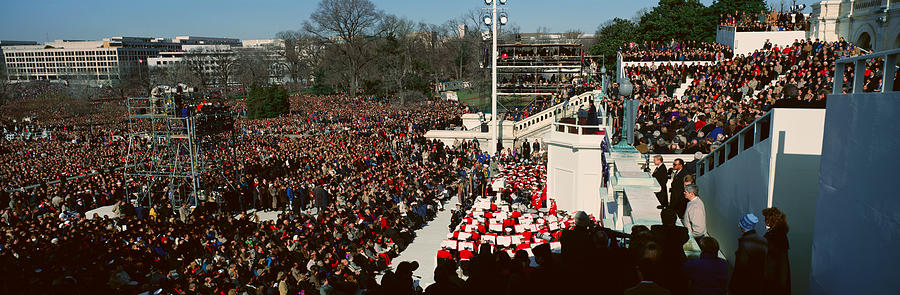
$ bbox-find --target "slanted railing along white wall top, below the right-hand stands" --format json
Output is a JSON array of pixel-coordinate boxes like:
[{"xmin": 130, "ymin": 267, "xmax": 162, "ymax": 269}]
[{"xmin": 696, "ymin": 110, "xmax": 774, "ymax": 177}]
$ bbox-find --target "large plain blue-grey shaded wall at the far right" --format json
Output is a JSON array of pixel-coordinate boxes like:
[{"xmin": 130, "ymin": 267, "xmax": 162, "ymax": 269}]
[{"xmin": 812, "ymin": 92, "xmax": 900, "ymax": 294}]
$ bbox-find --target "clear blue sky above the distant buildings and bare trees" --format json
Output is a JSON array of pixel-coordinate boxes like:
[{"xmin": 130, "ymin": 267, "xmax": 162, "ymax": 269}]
[{"xmin": 0, "ymin": 0, "xmax": 811, "ymax": 43}]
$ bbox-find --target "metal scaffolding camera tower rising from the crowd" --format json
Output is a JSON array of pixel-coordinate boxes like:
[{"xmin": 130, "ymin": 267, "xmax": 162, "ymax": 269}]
[{"xmin": 124, "ymin": 94, "xmax": 205, "ymax": 208}]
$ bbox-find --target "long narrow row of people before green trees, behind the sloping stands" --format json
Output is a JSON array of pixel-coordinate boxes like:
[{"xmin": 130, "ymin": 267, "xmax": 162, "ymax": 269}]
[{"xmin": 619, "ymin": 39, "xmax": 734, "ymax": 62}]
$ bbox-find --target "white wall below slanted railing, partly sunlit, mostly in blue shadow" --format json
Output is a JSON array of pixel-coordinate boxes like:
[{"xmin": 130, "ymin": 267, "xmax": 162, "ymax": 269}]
[{"xmin": 697, "ymin": 109, "xmax": 826, "ymax": 294}]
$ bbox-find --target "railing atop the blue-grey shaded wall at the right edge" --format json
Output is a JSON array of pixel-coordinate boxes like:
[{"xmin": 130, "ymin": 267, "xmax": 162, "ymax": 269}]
[{"xmin": 831, "ymin": 48, "xmax": 900, "ymax": 95}]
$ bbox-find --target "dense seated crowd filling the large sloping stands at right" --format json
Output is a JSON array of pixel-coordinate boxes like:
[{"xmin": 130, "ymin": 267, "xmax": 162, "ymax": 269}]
[{"xmin": 607, "ymin": 40, "xmax": 890, "ymax": 154}]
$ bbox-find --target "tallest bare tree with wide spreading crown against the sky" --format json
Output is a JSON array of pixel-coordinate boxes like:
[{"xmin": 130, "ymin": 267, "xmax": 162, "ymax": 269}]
[{"xmin": 303, "ymin": 0, "xmax": 383, "ymax": 95}]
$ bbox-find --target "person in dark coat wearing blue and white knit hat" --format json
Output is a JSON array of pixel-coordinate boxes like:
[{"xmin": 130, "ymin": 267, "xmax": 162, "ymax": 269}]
[{"xmin": 728, "ymin": 213, "xmax": 768, "ymax": 294}]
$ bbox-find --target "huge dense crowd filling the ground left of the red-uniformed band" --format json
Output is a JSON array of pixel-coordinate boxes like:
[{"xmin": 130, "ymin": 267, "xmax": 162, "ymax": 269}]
[{"xmin": 0, "ymin": 89, "xmax": 489, "ymax": 294}]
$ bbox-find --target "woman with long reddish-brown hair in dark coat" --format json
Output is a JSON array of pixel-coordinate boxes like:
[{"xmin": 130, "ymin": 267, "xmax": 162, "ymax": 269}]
[{"xmin": 762, "ymin": 207, "xmax": 791, "ymax": 294}]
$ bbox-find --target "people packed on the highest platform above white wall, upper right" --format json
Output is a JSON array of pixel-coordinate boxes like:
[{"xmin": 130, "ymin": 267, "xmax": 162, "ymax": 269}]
[{"xmin": 719, "ymin": 10, "xmax": 809, "ymax": 32}]
